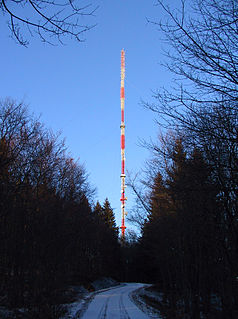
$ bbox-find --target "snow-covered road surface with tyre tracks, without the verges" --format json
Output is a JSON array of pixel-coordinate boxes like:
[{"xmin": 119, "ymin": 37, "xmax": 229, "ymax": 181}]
[{"xmin": 82, "ymin": 283, "xmax": 149, "ymax": 319}]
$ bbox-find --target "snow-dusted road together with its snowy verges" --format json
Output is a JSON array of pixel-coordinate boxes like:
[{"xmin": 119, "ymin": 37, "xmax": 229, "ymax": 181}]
[{"xmin": 67, "ymin": 283, "xmax": 163, "ymax": 319}]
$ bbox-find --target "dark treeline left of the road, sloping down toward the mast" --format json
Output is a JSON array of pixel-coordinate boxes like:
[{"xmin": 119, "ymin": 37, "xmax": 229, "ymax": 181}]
[{"xmin": 0, "ymin": 99, "xmax": 119, "ymax": 318}]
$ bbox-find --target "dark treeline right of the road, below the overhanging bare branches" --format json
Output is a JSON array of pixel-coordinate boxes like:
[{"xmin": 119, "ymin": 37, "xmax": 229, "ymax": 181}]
[{"xmin": 128, "ymin": 108, "xmax": 238, "ymax": 319}]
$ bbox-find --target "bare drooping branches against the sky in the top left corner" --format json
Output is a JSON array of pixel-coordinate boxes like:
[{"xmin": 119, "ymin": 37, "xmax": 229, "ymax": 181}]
[{"xmin": 0, "ymin": 0, "xmax": 96, "ymax": 46}]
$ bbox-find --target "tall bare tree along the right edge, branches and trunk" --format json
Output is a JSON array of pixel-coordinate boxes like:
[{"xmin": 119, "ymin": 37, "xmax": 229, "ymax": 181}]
[{"xmin": 141, "ymin": 0, "xmax": 238, "ymax": 318}]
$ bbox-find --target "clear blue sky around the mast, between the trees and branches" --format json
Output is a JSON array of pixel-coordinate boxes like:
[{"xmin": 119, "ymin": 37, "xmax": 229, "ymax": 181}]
[{"xmin": 0, "ymin": 0, "xmax": 178, "ymax": 229}]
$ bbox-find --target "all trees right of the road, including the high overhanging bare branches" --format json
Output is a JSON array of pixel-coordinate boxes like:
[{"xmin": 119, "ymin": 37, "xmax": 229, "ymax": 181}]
[{"xmin": 128, "ymin": 0, "xmax": 238, "ymax": 319}]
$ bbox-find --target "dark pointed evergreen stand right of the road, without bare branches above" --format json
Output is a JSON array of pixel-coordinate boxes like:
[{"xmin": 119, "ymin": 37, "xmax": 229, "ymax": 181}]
[{"xmin": 137, "ymin": 139, "xmax": 238, "ymax": 318}]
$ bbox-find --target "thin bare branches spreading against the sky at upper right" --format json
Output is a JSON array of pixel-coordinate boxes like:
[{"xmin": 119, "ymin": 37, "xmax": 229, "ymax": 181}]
[{"xmin": 147, "ymin": 0, "xmax": 238, "ymax": 130}]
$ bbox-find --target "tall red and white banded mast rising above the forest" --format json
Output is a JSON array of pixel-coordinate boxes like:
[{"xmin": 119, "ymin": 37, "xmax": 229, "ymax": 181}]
[{"xmin": 120, "ymin": 50, "xmax": 126, "ymax": 241}]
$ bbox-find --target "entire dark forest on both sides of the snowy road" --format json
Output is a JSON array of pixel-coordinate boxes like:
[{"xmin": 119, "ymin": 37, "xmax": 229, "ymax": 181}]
[{"xmin": 0, "ymin": 0, "xmax": 238, "ymax": 319}]
